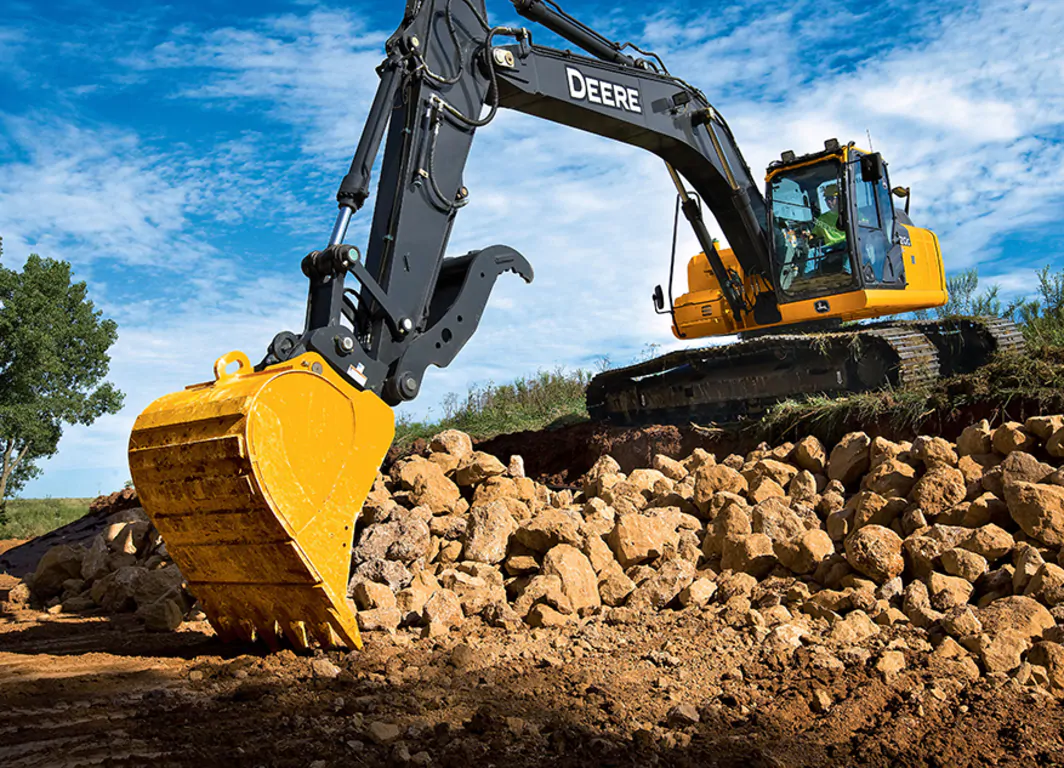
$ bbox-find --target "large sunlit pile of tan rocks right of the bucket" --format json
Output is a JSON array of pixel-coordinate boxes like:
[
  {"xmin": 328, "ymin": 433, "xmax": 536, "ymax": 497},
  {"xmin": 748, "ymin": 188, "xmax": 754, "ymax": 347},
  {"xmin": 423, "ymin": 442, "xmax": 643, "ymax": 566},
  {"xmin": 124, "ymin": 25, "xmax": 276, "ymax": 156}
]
[{"xmin": 350, "ymin": 416, "xmax": 1064, "ymax": 688}]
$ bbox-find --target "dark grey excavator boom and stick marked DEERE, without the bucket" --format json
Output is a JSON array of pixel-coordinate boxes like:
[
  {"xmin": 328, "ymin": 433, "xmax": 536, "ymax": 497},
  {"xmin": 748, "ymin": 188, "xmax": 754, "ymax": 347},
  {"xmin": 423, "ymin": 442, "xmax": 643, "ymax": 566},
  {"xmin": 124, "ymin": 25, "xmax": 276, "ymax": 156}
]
[{"xmin": 264, "ymin": 0, "xmax": 772, "ymax": 405}]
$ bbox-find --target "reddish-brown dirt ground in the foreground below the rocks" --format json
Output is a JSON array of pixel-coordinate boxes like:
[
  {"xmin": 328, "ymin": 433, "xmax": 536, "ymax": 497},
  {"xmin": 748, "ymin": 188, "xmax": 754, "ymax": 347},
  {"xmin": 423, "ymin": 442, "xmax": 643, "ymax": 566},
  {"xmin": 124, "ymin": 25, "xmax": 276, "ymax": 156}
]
[{"xmin": 0, "ymin": 577, "xmax": 1064, "ymax": 768}]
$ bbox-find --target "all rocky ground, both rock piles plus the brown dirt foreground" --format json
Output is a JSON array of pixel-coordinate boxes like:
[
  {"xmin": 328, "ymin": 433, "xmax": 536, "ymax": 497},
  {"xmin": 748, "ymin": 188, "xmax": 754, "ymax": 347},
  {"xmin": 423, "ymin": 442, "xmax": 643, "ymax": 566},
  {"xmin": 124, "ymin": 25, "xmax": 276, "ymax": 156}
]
[{"xmin": 6, "ymin": 416, "xmax": 1064, "ymax": 766}]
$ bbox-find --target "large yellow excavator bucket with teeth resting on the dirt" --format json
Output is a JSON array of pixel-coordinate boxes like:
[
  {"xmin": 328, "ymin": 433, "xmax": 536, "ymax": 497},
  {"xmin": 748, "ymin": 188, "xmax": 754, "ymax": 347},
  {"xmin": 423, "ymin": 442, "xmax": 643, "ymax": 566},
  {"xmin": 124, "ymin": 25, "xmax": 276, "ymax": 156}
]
[{"xmin": 129, "ymin": 352, "xmax": 395, "ymax": 648}]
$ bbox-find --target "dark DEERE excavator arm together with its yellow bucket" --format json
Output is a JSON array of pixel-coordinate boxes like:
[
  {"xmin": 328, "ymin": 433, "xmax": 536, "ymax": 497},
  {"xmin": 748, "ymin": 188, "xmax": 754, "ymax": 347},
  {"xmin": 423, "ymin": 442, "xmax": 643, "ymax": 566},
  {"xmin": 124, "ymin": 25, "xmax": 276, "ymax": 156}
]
[{"xmin": 129, "ymin": 0, "xmax": 772, "ymax": 647}]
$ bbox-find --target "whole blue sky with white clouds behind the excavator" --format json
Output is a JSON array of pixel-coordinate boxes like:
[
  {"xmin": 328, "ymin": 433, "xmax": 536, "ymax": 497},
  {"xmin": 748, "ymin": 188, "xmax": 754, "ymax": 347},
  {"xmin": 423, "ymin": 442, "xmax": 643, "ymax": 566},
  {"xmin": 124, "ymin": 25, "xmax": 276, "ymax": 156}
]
[{"xmin": 0, "ymin": 0, "xmax": 1064, "ymax": 496}]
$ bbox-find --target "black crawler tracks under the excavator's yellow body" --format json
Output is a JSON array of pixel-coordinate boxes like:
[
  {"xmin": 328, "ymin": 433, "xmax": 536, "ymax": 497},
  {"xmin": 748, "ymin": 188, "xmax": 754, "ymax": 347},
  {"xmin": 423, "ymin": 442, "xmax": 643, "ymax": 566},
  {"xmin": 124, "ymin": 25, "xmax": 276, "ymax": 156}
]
[{"xmin": 587, "ymin": 318, "xmax": 1023, "ymax": 425}]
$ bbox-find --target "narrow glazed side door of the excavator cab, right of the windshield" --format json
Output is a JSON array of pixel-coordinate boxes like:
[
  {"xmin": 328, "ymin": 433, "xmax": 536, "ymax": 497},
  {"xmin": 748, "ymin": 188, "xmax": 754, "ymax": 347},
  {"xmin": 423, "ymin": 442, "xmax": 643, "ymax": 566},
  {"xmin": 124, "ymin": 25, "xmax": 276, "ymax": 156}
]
[{"xmin": 849, "ymin": 150, "xmax": 905, "ymax": 288}]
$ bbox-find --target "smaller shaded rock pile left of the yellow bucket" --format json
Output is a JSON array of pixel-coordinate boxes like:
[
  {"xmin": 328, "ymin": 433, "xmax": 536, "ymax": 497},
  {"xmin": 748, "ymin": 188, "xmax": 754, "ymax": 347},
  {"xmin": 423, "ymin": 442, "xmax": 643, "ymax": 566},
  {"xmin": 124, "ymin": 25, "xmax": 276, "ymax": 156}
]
[{"xmin": 7, "ymin": 492, "xmax": 202, "ymax": 632}]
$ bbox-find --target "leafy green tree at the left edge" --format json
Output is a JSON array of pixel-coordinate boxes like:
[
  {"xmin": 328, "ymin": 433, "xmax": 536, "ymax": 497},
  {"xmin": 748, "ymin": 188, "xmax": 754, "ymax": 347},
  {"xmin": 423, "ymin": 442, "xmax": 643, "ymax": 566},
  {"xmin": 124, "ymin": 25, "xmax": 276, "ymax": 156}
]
[{"xmin": 0, "ymin": 241, "xmax": 122, "ymax": 503}]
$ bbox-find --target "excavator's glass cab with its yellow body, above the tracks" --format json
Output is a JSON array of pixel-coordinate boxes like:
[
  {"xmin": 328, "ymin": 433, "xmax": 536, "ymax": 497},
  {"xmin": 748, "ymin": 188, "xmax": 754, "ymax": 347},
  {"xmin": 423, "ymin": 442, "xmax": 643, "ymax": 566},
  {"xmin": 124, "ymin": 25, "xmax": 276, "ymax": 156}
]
[{"xmin": 672, "ymin": 139, "xmax": 948, "ymax": 339}]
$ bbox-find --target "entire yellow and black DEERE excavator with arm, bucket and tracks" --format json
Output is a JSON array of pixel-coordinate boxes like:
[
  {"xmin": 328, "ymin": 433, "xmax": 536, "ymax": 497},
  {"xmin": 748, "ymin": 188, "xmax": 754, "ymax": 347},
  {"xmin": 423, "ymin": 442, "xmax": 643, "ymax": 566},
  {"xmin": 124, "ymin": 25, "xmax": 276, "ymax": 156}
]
[{"xmin": 129, "ymin": 0, "xmax": 1019, "ymax": 648}]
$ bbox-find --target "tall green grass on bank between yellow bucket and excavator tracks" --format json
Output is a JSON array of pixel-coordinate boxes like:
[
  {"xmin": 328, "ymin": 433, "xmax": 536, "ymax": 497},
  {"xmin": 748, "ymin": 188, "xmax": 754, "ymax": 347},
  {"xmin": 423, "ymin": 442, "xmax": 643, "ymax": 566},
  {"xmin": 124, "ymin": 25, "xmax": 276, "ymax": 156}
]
[{"xmin": 395, "ymin": 368, "xmax": 592, "ymax": 449}]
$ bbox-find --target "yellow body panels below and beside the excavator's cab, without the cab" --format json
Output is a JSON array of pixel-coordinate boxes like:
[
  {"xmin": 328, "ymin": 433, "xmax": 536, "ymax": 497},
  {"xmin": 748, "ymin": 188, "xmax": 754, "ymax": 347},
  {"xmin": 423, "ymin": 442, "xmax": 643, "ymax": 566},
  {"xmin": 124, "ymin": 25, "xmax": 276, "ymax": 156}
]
[{"xmin": 672, "ymin": 227, "xmax": 949, "ymax": 338}]
